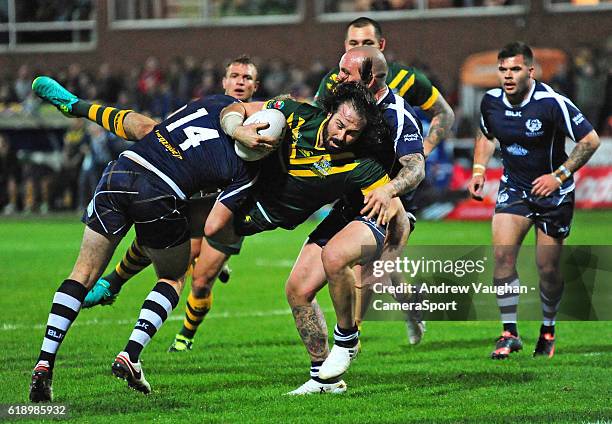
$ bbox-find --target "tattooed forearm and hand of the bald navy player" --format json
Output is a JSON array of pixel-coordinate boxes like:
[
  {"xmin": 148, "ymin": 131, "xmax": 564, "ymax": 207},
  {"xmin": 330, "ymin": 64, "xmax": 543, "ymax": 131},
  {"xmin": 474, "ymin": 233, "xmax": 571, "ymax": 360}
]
[{"xmin": 360, "ymin": 153, "xmax": 425, "ymax": 224}]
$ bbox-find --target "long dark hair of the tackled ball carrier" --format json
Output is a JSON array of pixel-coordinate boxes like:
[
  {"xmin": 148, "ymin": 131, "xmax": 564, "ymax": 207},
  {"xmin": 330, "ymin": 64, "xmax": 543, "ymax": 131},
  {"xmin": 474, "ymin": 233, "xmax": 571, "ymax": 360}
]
[{"xmin": 321, "ymin": 81, "xmax": 390, "ymax": 147}]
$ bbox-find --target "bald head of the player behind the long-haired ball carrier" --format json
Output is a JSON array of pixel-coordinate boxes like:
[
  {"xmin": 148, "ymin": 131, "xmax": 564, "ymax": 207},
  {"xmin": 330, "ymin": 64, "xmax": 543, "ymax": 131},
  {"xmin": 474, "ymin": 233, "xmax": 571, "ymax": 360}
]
[{"xmin": 338, "ymin": 46, "xmax": 388, "ymax": 92}]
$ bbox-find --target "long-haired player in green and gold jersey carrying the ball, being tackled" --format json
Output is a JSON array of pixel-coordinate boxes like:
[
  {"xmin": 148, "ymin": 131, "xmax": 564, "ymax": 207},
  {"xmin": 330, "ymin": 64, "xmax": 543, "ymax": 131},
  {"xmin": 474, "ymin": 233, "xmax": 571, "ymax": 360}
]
[{"xmin": 222, "ymin": 83, "xmax": 395, "ymax": 236}]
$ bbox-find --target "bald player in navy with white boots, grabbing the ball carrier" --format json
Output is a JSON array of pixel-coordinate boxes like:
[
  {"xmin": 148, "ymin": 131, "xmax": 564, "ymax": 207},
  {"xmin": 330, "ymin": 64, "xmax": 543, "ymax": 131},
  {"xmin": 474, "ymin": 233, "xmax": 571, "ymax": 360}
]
[{"xmin": 286, "ymin": 46, "xmax": 425, "ymax": 395}]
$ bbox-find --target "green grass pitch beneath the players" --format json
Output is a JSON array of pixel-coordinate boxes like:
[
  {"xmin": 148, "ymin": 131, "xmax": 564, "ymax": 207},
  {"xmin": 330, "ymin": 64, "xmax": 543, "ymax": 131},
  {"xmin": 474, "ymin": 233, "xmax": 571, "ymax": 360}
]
[{"xmin": 0, "ymin": 212, "xmax": 612, "ymax": 423}]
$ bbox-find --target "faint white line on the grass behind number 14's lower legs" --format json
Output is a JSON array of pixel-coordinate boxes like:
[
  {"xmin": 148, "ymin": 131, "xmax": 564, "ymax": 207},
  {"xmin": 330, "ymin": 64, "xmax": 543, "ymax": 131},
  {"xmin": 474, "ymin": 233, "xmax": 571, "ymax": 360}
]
[{"xmin": 0, "ymin": 308, "xmax": 291, "ymax": 331}]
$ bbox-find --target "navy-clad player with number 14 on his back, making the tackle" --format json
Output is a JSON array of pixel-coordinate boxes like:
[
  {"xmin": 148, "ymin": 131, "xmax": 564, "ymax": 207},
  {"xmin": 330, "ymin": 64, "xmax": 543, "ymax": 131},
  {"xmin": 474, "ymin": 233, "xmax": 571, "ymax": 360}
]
[{"xmin": 30, "ymin": 93, "xmax": 258, "ymax": 402}]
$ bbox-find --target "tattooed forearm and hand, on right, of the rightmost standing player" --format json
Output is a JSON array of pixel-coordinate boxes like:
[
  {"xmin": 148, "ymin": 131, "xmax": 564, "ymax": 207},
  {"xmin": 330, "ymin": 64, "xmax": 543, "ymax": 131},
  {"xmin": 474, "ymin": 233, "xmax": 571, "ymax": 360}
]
[{"xmin": 531, "ymin": 130, "xmax": 601, "ymax": 196}]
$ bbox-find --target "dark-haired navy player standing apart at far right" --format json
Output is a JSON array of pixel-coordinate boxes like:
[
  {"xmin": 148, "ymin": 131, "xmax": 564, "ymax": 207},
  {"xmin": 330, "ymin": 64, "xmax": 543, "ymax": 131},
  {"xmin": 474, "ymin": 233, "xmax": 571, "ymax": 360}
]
[{"xmin": 469, "ymin": 42, "xmax": 600, "ymax": 359}]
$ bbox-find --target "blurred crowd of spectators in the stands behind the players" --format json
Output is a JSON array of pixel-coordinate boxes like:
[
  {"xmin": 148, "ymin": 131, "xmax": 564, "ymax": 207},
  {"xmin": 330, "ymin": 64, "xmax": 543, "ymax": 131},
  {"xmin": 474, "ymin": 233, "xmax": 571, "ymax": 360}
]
[{"xmin": 0, "ymin": 43, "xmax": 612, "ymax": 214}]
